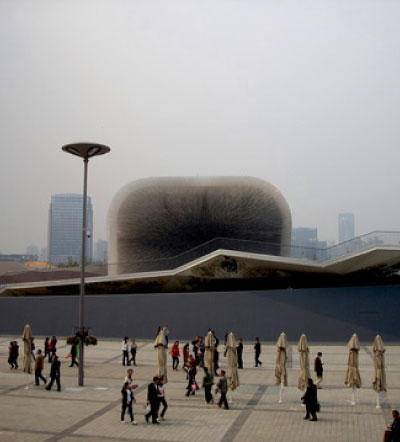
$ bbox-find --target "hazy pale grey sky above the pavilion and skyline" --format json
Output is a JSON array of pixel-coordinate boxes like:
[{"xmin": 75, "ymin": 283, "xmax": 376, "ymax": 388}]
[{"xmin": 0, "ymin": 0, "xmax": 400, "ymax": 253}]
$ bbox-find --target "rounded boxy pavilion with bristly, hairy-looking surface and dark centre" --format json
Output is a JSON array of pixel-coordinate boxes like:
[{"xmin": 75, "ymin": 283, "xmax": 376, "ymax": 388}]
[{"xmin": 108, "ymin": 177, "xmax": 292, "ymax": 274}]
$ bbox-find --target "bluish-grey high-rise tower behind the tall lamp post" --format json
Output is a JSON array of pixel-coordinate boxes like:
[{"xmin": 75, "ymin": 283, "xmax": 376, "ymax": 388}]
[{"xmin": 48, "ymin": 193, "xmax": 93, "ymax": 265}]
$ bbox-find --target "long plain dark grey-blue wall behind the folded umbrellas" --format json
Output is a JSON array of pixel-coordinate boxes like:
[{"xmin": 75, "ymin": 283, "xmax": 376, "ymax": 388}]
[{"xmin": 0, "ymin": 286, "xmax": 400, "ymax": 343}]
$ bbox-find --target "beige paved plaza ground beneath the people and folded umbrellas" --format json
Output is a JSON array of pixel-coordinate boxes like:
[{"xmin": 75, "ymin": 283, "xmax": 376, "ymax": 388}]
[{"xmin": 0, "ymin": 331, "xmax": 400, "ymax": 442}]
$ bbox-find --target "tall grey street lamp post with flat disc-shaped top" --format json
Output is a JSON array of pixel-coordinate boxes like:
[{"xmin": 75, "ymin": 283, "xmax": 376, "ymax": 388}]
[{"xmin": 62, "ymin": 143, "xmax": 110, "ymax": 386}]
